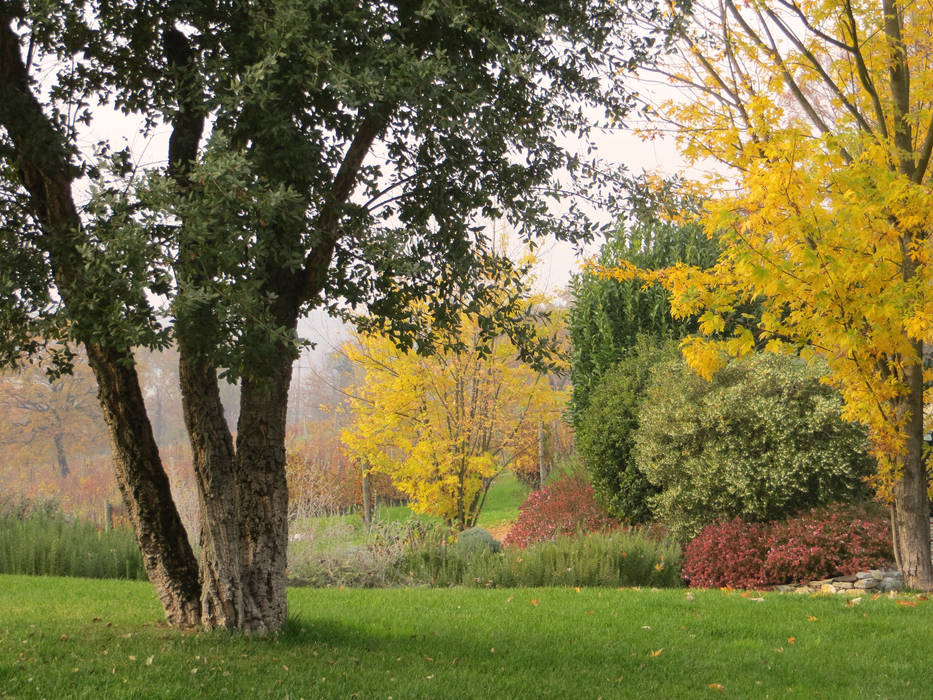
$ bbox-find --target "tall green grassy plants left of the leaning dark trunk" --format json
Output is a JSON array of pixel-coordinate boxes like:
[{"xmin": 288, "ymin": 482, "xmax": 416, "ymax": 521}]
[{"xmin": 0, "ymin": 502, "xmax": 146, "ymax": 580}]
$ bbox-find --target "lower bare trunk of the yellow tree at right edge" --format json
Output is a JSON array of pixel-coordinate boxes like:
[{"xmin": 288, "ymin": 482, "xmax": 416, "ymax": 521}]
[{"xmin": 892, "ymin": 350, "xmax": 933, "ymax": 591}]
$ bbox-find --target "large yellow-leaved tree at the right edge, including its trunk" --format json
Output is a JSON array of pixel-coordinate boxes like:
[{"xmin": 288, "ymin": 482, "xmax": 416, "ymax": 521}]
[{"xmin": 613, "ymin": 0, "xmax": 933, "ymax": 588}]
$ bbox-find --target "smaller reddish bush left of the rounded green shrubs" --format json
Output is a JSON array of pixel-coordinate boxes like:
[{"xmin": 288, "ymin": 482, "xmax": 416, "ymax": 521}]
[{"xmin": 503, "ymin": 476, "xmax": 619, "ymax": 547}]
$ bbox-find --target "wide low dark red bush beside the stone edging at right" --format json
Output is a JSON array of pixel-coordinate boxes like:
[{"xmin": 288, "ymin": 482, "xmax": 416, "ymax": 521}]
[{"xmin": 684, "ymin": 506, "xmax": 893, "ymax": 588}]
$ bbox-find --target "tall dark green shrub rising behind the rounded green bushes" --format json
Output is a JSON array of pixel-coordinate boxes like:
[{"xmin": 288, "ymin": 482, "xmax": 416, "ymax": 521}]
[{"xmin": 570, "ymin": 182, "xmax": 719, "ymax": 428}]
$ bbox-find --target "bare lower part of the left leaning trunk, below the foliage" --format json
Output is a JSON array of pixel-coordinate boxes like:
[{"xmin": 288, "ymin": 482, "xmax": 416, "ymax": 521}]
[{"xmin": 85, "ymin": 343, "xmax": 201, "ymax": 627}]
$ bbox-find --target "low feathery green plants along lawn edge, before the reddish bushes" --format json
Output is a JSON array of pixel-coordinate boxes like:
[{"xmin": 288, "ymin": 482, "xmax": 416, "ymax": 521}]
[{"xmin": 390, "ymin": 530, "xmax": 681, "ymax": 588}]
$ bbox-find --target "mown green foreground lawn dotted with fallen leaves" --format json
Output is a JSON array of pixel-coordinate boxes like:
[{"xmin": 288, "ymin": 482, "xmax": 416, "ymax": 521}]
[{"xmin": 0, "ymin": 576, "xmax": 933, "ymax": 699}]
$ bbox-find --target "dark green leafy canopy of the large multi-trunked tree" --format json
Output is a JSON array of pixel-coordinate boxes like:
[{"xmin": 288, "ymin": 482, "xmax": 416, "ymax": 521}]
[{"xmin": 0, "ymin": 0, "xmax": 684, "ymax": 374}]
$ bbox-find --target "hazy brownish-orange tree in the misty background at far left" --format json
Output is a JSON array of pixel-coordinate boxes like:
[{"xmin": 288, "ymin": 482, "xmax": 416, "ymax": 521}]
[{"xmin": 0, "ymin": 358, "xmax": 107, "ymax": 478}]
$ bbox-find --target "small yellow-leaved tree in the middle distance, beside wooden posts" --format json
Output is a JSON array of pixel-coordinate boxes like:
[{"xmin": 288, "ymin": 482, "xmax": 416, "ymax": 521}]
[{"xmin": 342, "ymin": 304, "xmax": 566, "ymax": 530}]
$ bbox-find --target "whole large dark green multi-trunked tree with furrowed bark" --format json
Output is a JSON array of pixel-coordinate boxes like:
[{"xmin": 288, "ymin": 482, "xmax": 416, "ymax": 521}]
[{"xmin": 0, "ymin": 0, "xmax": 672, "ymax": 633}]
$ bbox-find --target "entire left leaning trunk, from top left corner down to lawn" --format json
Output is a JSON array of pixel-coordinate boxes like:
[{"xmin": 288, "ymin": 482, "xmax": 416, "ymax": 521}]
[{"xmin": 0, "ymin": 11, "xmax": 200, "ymax": 625}]
